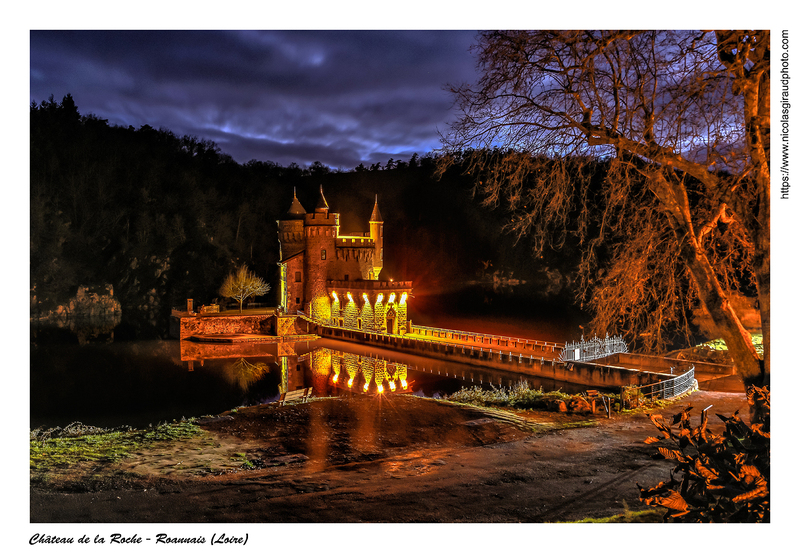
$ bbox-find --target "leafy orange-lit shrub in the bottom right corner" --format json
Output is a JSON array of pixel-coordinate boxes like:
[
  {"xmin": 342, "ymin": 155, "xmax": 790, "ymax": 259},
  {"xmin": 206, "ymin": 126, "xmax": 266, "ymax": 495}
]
[{"xmin": 637, "ymin": 386, "xmax": 770, "ymax": 522}]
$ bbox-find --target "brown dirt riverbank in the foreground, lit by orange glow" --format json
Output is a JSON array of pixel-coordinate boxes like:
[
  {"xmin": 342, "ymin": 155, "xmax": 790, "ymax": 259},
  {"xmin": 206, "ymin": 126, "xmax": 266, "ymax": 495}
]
[{"xmin": 30, "ymin": 391, "xmax": 747, "ymax": 523}]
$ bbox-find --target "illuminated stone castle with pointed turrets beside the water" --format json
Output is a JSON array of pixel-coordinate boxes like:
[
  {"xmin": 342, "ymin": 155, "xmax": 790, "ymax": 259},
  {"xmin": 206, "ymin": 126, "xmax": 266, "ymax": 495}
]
[{"xmin": 278, "ymin": 186, "xmax": 412, "ymax": 334}]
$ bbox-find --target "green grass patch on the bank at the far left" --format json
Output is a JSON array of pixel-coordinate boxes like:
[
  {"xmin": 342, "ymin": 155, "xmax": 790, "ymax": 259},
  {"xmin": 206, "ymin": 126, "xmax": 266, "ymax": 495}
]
[{"xmin": 30, "ymin": 419, "xmax": 202, "ymax": 473}]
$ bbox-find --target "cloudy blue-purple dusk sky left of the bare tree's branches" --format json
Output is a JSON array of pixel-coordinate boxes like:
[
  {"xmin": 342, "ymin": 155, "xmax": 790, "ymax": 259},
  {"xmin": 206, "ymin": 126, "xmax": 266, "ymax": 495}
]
[{"xmin": 30, "ymin": 31, "xmax": 476, "ymax": 169}]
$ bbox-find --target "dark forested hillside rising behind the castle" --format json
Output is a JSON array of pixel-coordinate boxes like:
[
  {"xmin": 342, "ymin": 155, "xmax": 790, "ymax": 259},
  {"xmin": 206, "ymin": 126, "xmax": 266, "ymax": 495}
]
[{"xmin": 30, "ymin": 95, "xmax": 576, "ymax": 336}]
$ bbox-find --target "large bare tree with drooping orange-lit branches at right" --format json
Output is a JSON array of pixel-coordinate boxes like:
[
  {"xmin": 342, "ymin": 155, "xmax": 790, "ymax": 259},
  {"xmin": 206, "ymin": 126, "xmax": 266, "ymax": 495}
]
[{"xmin": 440, "ymin": 31, "xmax": 770, "ymax": 385}]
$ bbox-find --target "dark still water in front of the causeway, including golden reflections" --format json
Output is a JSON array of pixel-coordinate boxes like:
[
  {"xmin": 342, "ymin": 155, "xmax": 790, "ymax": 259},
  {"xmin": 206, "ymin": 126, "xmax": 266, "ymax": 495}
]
[{"xmin": 30, "ymin": 333, "xmax": 580, "ymax": 428}]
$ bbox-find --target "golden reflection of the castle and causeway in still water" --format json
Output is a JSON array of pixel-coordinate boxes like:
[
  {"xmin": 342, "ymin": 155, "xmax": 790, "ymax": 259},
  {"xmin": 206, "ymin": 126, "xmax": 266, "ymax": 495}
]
[{"xmin": 180, "ymin": 332, "xmax": 579, "ymax": 405}]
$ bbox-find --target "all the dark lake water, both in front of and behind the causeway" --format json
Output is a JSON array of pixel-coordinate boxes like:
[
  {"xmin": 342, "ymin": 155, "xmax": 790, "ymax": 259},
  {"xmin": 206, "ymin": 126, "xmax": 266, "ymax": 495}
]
[{"xmin": 30, "ymin": 287, "xmax": 582, "ymax": 428}]
